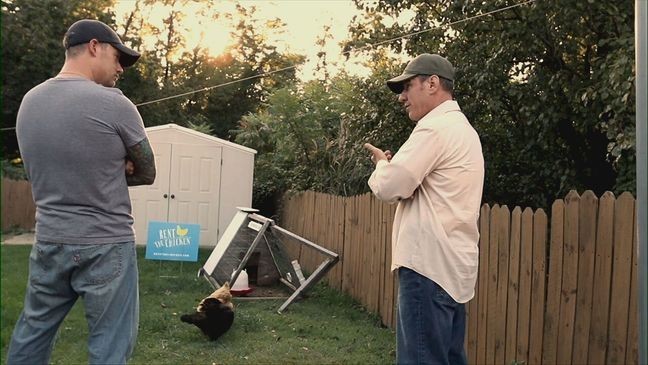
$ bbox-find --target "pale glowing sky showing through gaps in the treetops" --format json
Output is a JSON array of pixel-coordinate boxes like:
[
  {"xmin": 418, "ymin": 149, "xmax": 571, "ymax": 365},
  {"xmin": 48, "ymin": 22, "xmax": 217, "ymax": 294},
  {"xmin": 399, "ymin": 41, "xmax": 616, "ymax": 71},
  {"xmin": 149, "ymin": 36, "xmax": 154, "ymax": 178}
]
[{"xmin": 115, "ymin": 0, "xmax": 368, "ymax": 80}]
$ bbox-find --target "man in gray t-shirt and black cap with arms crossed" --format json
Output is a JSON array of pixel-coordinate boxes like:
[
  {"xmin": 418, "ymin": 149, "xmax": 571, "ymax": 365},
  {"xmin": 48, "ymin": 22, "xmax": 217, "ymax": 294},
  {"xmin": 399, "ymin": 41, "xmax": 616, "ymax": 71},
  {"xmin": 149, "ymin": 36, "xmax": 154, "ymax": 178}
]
[{"xmin": 7, "ymin": 20, "xmax": 155, "ymax": 364}]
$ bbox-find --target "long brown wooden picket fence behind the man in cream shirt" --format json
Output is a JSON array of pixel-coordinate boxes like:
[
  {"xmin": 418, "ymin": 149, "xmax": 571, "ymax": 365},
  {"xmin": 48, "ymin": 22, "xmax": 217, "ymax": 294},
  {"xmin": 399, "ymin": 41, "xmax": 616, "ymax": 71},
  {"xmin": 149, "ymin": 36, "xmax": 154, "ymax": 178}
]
[{"xmin": 281, "ymin": 191, "xmax": 638, "ymax": 364}]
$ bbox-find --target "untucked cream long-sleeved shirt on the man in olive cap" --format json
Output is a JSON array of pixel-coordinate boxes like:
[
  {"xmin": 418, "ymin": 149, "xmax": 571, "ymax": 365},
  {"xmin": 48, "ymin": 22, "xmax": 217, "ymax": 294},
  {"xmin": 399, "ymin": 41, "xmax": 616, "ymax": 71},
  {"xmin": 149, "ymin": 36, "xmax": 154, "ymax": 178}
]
[{"xmin": 369, "ymin": 101, "xmax": 484, "ymax": 303}]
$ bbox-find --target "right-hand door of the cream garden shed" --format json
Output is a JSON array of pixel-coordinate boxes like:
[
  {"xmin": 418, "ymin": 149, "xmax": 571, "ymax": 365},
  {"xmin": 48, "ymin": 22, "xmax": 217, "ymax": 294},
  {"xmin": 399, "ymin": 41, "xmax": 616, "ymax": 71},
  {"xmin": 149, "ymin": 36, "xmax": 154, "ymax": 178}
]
[{"xmin": 168, "ymin": 144, "xmax": 222, "ymax": 245}]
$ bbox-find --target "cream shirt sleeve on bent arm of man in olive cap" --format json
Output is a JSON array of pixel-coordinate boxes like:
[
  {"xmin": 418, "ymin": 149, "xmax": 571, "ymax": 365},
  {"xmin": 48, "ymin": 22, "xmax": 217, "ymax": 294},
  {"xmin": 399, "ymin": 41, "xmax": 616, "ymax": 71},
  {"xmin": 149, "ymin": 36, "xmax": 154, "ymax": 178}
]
[{"xmin": 369, "ymin": 123, "xmax": 443, "ymax": 202}]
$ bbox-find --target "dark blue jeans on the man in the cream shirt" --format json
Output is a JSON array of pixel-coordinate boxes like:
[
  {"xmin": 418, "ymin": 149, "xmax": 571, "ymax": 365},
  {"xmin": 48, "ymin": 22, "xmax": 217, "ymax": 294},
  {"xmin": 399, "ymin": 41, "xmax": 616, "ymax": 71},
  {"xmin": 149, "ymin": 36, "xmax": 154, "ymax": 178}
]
[{"xmin": 396, "ymin": 267, "xmax": 467, "ymax": 365}]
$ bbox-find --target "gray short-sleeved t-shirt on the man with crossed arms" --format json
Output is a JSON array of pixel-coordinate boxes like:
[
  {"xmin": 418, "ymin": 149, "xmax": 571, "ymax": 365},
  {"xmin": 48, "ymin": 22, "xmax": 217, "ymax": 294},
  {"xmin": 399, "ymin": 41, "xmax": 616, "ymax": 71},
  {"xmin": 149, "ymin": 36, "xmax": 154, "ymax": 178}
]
[{"xmin": 16, "ymin": 78, "xmax": 146, "ymax": 244}]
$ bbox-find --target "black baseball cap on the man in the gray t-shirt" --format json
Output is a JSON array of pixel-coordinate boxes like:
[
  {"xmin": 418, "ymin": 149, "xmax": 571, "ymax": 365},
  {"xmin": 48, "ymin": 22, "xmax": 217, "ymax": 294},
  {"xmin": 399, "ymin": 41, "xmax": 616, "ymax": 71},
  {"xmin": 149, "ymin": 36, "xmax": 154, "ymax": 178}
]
[{"xmin": 63, "ymin": 19, "xmax": 140, "ymax": 67}]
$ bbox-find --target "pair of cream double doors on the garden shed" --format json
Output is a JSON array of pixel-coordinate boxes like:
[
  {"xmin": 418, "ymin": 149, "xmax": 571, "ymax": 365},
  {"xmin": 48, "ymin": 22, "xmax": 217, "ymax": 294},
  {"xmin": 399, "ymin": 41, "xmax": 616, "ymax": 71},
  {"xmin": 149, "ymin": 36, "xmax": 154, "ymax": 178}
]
[{"xmin": 130, "ymin": 143, "xmax": 222, "ymax": 245}]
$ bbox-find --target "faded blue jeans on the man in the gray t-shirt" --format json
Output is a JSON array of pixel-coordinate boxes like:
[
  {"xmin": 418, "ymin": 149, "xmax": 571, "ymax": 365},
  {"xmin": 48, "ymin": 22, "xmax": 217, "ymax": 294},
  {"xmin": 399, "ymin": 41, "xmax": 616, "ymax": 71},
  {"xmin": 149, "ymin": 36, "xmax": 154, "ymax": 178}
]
[{"xmin": 7, "ymin": 241, "xmax": 139, "ymax": 365}]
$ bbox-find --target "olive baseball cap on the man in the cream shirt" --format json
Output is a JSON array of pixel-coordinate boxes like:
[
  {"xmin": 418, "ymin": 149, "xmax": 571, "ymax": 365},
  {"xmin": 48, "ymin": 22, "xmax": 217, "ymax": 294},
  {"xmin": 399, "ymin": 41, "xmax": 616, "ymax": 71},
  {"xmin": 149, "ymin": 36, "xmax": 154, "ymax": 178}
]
[{"xmin": 387, "ymin": 53, "xmax": 454, "ymax": 94}]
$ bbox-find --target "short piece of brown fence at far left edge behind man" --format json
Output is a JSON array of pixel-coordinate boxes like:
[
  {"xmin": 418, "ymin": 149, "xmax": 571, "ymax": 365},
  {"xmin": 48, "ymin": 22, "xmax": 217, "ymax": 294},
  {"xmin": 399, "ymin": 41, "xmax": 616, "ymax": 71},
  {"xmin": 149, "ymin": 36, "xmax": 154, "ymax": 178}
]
[{"xmin": 2, "ymin": 178, "xmax": 36, "ymax": 230}]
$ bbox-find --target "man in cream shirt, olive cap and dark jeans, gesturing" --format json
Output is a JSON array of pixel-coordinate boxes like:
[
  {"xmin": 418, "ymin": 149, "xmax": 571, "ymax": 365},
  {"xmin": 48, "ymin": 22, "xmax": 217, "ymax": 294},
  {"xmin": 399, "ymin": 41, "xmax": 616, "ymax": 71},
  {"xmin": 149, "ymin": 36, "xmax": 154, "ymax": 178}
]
[{"xmin": 365, "ymin": 53, "xmax": 484, "ymax": 364}]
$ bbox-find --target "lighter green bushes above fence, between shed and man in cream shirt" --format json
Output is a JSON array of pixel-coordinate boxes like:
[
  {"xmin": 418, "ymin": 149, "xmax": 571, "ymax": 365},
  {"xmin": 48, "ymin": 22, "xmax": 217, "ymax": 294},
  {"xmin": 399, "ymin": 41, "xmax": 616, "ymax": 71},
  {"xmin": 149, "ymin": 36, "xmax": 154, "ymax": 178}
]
[{"xmin": 236, "ymin": 55, "xmax": 422, "ymax": 206}]
